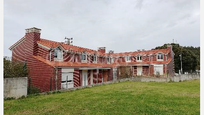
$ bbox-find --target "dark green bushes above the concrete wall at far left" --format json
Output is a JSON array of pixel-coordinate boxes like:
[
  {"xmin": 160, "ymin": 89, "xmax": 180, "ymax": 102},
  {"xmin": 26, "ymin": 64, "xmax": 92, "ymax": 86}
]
[{"xmin": 4, "ymin": 57, "xmax": 28, "ymax": 78}]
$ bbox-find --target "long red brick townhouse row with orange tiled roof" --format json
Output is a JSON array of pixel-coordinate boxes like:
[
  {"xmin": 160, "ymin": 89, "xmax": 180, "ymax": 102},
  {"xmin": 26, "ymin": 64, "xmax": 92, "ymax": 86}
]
[{"xmin": 10, "ymin": 27, "xmax": 174, "ymax": 92}]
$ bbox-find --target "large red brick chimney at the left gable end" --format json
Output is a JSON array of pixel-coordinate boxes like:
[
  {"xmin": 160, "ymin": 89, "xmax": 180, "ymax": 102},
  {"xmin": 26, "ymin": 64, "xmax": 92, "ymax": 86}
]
[{"xmin": 25, "ymin": 27, "xmax": 41, "ymax": 57}]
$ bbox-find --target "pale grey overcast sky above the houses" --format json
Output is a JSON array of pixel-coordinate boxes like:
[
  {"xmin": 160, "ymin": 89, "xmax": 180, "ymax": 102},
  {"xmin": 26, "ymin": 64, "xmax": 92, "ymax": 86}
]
[{"xmin": 4, "ymin": 0, "xmax": 200, "ymax": 56}]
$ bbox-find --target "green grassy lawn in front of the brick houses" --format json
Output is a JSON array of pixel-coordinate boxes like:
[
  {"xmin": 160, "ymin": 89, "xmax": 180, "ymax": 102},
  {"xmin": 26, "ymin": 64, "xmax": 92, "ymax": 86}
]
[{"xmin": 4, "ymin": 80, "xmax": 200, "ymax": 115}]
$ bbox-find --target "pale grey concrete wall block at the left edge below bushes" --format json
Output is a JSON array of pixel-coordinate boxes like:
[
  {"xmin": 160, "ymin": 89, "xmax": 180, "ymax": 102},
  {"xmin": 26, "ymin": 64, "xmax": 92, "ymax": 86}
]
[{"xmin": 4, "ymin": 77, "xmax": 28, "ymax": 98}]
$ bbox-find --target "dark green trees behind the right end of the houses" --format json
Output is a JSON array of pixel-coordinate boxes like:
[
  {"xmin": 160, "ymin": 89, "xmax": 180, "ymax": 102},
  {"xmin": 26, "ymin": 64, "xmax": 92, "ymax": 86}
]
[{"xmin": 155, "ymin": 43, "xmax": 200, "ymax": 73}]
